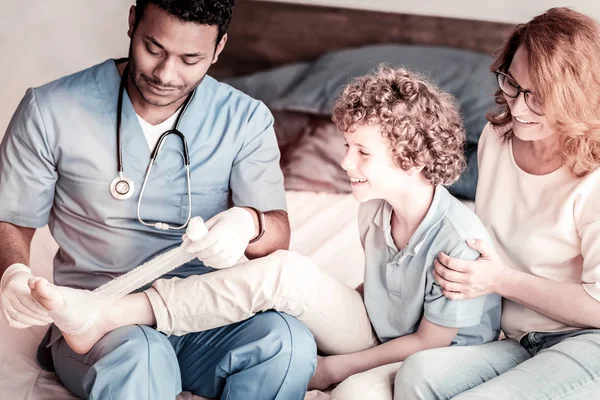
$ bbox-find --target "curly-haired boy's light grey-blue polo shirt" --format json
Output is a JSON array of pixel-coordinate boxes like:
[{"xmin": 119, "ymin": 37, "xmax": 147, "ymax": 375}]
[{"xmin": 358, "ymin": 186, "xmax": 501, "ymax": 345}]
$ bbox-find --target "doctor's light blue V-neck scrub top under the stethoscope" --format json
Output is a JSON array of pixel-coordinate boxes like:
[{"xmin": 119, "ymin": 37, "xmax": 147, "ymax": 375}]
[{"xmin": 0, "ymin": 59, "xmax": 286, "ymax": 290}]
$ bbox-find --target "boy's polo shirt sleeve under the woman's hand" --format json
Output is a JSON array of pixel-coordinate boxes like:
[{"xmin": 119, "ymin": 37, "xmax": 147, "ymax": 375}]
[{"xmin": 424, "ymin": 245, "xmax": 487, "ymax": 328}]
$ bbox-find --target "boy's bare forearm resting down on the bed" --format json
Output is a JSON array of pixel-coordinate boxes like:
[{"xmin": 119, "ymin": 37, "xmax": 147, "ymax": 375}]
[{"xmin": 328, "ymin": 317, "xmax": 459, "ymax": 383}]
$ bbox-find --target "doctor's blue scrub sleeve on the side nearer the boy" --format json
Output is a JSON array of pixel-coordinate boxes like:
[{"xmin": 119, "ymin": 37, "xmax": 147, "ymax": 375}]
[{"xmin": 230, "ymin": 102, "xmax": 287, "ymax": 211}]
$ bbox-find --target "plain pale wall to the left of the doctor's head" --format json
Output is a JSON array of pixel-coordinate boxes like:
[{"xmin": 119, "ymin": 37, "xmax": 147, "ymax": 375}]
[{"xmin": 0, "ymin": 0, "xmax": 135, "ymax": 137}]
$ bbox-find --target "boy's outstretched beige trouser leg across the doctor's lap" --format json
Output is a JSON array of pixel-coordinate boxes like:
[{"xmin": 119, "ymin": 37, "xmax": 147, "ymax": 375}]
[{"xmin": 145, "ymin": 250, "xmax": 377, "ymax": 354}]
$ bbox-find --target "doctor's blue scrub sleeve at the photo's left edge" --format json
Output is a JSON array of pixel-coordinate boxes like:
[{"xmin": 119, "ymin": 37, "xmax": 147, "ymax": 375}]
[{"xmin": 0, "ymin": 89, "xmax": 58, "ymax": 228}]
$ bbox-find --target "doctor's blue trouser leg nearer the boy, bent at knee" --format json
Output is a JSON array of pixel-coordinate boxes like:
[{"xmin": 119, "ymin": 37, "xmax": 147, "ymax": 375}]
[{"xmin": 169, "ymin": 311, "xmax": 317, "ymax": 400}]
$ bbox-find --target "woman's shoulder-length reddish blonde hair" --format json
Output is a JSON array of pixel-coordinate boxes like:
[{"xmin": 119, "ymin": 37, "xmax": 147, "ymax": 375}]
[{"xmin": 487, "ymin": 7, "xmax": 600, "ymax": 176}]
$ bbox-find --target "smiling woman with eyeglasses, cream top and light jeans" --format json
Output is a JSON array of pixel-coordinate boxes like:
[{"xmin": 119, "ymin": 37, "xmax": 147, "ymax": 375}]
[{"xmin": 395, "ymin": 8, "xmax": 600, "ymax": 400}]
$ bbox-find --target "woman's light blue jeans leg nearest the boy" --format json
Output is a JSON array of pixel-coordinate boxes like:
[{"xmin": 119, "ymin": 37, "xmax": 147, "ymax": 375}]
[{"xmin": 394, "ymin": 339, "xmax": 531, "ymax": 400}]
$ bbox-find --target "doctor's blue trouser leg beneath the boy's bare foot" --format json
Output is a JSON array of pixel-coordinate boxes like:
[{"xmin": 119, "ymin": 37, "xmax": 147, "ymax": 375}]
[{"xmin": 51, "ymin": 326, "xmax": 181, "ymax": 400}]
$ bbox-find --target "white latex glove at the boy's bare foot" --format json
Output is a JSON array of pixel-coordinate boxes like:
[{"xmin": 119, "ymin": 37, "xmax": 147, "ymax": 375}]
[{"xmin": 0, "ymin": 264, "xmax": 53, "ymax": 329}]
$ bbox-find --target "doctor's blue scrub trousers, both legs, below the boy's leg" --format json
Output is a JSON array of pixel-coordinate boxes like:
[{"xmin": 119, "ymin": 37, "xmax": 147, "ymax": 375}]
[{"xmin": 51, "ymin": 311, "xmax": 317, "ymax": 400}]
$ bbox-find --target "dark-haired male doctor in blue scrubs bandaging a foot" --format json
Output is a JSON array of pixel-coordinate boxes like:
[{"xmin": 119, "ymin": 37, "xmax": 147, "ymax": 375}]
[{"xmin": 0, "ymin": 0, "xmax": 316, "ymax": 400}]
